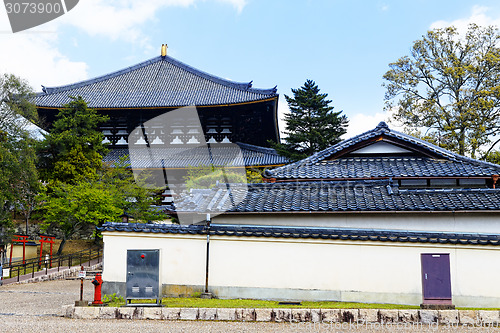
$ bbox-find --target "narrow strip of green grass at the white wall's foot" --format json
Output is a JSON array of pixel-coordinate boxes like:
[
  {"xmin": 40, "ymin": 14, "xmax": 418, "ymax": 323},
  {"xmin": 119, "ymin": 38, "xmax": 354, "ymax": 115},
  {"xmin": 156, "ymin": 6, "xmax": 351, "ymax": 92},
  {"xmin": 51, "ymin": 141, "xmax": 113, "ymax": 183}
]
[{"xmin": 108, "ymin": 297, "xmax": 419, "ymax": 309}]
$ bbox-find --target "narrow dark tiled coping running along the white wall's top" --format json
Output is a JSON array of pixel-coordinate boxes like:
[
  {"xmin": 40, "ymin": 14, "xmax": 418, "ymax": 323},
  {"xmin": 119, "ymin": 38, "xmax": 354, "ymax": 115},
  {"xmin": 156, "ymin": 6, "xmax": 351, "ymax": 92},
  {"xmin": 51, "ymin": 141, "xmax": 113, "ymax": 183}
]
[{"xmin": 99, "ymin": 222, "xmax": 500, "ymax": 245}]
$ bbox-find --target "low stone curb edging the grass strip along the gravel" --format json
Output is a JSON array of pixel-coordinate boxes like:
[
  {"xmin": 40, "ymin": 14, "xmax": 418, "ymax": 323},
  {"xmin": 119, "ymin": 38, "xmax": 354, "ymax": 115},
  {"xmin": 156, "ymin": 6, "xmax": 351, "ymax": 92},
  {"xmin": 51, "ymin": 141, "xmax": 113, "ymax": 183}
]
[{"xmin": 62, "ymin": 305, "xmax": 500, "ymax": 327}]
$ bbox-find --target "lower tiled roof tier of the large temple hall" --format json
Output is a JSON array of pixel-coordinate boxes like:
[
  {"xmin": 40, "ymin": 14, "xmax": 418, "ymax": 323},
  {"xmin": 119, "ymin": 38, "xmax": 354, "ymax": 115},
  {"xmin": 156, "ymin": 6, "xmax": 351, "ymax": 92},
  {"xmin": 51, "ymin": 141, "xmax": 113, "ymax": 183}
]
[{"xmin": 104, "ymin": 143, "xmax": 288, "ymax": 169}]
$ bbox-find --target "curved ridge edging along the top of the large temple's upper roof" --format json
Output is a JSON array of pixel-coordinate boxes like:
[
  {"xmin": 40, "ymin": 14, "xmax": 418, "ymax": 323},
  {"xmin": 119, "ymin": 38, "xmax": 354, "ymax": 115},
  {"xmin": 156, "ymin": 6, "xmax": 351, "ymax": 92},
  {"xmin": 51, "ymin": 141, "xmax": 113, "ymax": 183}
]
[{"xmin": 38, "ymin": 56, "xmax": 277, "ymax": 96}]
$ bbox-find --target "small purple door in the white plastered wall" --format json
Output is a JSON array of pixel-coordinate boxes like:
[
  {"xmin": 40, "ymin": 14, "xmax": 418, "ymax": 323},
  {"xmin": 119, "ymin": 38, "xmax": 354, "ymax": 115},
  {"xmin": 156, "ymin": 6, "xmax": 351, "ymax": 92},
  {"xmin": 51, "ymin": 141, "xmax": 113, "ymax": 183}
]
[{"xmin": 420, "ymin": 253, "xmax": 451, "ymax": 301}]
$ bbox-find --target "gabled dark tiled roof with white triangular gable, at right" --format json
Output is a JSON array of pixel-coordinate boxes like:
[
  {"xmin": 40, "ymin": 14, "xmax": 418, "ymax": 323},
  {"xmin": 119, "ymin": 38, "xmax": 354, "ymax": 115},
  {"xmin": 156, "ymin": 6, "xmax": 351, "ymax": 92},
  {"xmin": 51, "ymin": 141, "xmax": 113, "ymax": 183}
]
[{"xmin": 265, "ymin": 122, "xmax": 500, "ymax": 179}]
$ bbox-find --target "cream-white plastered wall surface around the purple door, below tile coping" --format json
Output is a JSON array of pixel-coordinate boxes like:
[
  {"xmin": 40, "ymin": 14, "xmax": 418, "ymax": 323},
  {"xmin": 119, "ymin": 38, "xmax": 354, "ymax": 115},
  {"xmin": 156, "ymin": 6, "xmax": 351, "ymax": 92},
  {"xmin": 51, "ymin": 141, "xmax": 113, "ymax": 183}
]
[{"xmin": 103, "ymin": 232, "xmax": 500, "ymax": 307}]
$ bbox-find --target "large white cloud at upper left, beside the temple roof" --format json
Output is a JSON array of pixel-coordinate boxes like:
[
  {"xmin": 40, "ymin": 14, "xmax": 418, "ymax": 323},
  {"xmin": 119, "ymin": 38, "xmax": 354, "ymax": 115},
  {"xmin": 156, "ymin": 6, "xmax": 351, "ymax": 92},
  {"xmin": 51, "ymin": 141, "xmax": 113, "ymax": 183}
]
[{"xmin": 0, "ymin": 0, "xmax": 246, "ymax": 91}]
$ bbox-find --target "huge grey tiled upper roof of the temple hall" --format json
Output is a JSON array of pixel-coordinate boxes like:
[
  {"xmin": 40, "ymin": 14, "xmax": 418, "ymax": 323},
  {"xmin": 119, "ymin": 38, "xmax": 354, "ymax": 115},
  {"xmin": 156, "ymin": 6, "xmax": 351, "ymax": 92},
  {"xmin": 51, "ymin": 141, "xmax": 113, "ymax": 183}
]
[{"xmin": 35, "ymin": 56, "xmax": 277, "ymax": 108}]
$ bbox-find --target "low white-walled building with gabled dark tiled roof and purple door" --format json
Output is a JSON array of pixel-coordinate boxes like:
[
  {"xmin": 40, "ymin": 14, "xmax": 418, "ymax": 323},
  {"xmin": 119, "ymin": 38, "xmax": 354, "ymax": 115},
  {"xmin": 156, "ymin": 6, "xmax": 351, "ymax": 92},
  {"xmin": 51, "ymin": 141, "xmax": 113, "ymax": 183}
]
[{"xmin": 102, "ymin": 123, "xmax": 500, "ymax": 307}]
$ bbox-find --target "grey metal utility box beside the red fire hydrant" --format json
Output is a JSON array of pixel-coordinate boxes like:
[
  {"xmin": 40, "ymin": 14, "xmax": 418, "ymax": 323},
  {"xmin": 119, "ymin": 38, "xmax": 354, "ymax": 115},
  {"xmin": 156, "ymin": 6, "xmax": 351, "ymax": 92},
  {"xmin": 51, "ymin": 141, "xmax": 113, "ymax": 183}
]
[{"xmin": 126, "ymin": 250, "xmax": 161, "ymax": 305}]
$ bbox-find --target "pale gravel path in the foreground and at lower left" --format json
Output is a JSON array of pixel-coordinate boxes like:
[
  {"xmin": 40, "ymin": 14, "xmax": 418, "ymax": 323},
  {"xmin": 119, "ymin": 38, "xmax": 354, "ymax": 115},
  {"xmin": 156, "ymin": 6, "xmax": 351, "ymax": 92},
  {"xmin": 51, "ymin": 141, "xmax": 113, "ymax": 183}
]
[{"xmin": 0, "ymin": 280, "xmax": 500, "ymax": 333}]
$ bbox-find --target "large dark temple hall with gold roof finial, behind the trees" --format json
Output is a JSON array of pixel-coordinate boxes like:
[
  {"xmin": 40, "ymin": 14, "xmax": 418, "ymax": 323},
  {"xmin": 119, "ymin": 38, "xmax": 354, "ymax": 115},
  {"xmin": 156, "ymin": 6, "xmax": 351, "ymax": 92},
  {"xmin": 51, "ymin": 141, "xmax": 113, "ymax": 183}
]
[{"xmin": 36, "ymin": 45, "xmax": 287, "ymax": 167}]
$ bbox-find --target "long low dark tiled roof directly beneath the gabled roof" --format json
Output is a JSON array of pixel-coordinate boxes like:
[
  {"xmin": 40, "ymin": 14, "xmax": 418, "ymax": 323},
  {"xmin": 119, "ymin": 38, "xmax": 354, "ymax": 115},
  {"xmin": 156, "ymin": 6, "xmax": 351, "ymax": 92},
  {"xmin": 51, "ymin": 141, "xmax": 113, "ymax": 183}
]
[{"xmin": 175, "ymin": 180, "xmax": 500, "ymax": 214}]
